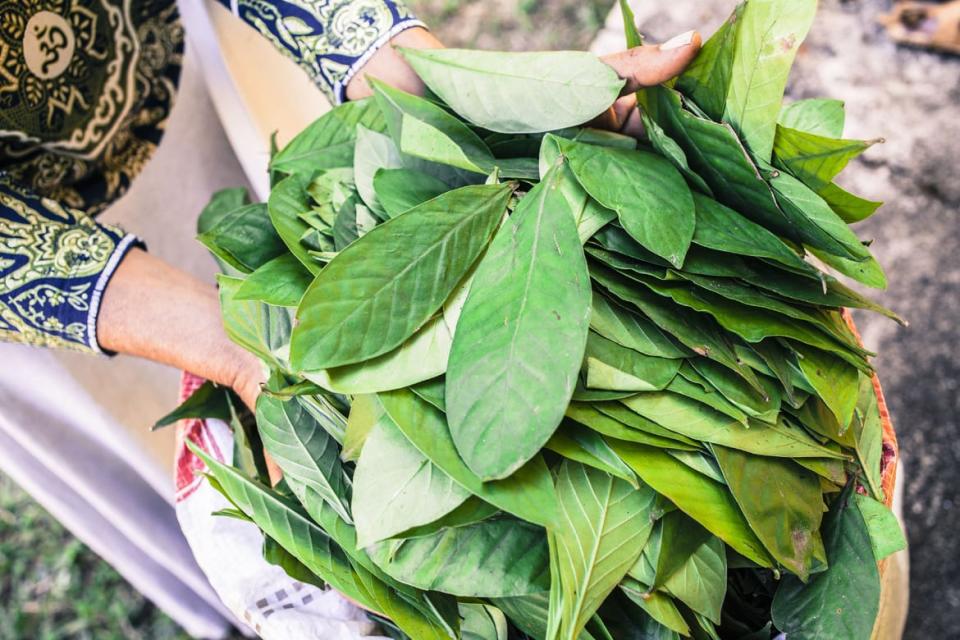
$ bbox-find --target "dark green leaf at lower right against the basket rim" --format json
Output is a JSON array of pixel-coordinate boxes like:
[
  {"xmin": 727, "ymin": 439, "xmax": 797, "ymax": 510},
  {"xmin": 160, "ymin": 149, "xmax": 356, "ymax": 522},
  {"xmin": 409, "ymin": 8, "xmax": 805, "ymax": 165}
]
[{"xmin": 771, "ymin": 488, "xmax": 880, "ymax": 640}]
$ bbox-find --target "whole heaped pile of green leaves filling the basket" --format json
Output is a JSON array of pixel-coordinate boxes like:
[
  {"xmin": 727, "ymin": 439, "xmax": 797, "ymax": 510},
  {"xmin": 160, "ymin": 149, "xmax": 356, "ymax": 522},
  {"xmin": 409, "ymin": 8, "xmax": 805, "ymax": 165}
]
[{"xmin": 186, "ymin": 0, "xmax": 905, "ymax": 640}]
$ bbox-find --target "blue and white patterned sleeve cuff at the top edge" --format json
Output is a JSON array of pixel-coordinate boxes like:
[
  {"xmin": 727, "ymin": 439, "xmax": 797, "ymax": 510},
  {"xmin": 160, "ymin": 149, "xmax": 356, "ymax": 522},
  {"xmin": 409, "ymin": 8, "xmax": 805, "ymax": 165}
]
[{"xmin": 217, "ymin": 0, "xmax": 424, "ymax": 104}]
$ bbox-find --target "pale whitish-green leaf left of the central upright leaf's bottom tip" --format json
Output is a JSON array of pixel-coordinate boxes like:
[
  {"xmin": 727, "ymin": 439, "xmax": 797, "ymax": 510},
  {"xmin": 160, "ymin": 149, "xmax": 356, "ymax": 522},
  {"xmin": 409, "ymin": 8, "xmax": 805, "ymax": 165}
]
[{"xmin": 353, "ymin": 420, "xmax": 470, "ymax": 547}]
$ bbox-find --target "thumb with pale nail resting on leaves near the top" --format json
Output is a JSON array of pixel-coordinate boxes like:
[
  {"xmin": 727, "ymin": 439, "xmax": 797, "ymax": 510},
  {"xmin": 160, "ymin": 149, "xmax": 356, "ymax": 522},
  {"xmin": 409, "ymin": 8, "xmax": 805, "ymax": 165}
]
[{"xmin": 601, "ymin": 31, "xmax": 701, "ymax": 94}]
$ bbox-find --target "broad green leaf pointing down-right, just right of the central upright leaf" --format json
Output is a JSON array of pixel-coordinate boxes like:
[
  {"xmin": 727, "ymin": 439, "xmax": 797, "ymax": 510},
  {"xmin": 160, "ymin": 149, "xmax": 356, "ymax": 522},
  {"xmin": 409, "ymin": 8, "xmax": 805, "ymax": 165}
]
[{"xmin": 561, "ymin": 141, "xmax": 696, "ymax": 267}]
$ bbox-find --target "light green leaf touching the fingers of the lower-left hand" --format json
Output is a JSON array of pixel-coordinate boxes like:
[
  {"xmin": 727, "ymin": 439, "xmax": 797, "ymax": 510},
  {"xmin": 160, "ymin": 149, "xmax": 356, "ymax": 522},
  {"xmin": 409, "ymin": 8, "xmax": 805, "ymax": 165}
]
[{"xmin": 217, "ymin": 274, "xmax": 293, "ymax": 370}]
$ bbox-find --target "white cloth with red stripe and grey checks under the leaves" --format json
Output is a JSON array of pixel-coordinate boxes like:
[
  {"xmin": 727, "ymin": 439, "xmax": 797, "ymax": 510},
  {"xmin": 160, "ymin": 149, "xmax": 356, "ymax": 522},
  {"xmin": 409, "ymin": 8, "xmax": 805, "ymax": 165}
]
[{"xmin": 176, "ymin": 374, "xmax": 388, "ymax": 640}]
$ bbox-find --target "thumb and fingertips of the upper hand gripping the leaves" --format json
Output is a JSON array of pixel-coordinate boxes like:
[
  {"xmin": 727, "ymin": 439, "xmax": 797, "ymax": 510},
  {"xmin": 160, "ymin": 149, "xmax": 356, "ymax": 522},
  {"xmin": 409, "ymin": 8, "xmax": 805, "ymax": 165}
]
[{"xmin": 593, "ymin": 31, "xmax": 701, "ymax": 137}]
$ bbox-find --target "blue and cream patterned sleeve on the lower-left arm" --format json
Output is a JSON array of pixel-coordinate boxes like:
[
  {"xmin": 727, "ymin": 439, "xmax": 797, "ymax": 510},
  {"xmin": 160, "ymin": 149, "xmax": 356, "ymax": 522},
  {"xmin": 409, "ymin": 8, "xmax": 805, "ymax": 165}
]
[{"xmin": 0, "ymin": 172, "xmax": 140, "ymax": 353}]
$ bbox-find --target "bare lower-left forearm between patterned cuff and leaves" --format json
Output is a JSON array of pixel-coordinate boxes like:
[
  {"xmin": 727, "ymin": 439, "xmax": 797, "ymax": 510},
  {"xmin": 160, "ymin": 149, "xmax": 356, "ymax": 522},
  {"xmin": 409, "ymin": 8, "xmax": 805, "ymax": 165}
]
[{"xmin": 97, "ymin": 249, "xmax": 260, "ymax": 401}]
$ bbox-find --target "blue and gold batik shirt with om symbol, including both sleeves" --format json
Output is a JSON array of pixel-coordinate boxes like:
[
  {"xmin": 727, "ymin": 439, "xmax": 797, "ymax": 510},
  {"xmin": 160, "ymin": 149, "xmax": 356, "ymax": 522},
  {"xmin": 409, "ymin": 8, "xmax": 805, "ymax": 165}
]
[{"xmin": 0, "ymin": 0, "xmax": 421, "ymax": 352}]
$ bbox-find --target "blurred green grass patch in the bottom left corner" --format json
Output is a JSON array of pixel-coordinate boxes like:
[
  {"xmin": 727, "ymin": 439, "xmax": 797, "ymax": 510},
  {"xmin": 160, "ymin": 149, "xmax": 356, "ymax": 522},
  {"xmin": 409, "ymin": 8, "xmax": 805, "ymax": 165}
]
[{"xmin": 0, "ymin": 475, "xmax": 196, "ymax": 640}]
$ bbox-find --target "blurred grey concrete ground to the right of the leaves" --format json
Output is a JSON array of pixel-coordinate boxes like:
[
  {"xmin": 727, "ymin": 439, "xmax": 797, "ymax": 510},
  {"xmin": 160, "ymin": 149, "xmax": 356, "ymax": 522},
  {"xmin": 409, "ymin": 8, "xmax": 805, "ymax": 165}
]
[{"xmin": 595, "ymin": 0, "xmax": 960, "ymax": 640}]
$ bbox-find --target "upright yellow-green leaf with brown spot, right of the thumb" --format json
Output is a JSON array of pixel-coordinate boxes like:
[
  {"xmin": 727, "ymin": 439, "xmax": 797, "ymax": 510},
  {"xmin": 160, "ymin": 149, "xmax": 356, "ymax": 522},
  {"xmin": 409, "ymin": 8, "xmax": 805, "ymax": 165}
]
[{"xmin": 723, "ymin": 0, "xmax": 817, "ymax": 161}]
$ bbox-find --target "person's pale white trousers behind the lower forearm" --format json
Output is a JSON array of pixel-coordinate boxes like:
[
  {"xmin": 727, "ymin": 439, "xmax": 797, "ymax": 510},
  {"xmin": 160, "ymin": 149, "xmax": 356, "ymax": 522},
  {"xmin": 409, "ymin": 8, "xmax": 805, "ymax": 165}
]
[{"xmin": 0, "ymin": 45, "xmax": 246, "ymax": 638}]
